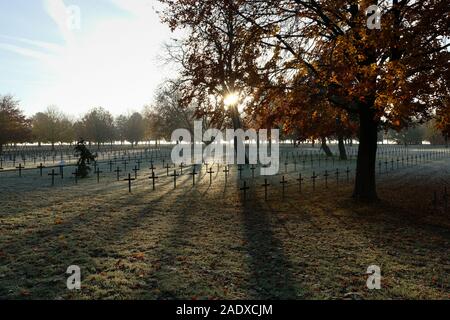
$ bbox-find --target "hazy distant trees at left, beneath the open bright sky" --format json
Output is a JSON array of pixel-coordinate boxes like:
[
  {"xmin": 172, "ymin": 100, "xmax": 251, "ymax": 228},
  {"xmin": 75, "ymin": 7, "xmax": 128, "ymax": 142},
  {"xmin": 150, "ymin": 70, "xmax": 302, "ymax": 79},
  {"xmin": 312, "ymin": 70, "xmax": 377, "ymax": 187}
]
[{"xmin": 0, "ymin": 95, "xmax": 167, "ymax": 153}]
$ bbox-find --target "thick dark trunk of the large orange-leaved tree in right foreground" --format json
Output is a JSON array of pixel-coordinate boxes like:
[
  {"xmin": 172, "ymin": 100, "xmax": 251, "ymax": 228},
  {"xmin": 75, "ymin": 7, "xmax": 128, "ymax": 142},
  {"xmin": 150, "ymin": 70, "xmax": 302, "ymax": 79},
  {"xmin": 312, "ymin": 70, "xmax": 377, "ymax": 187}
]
[{"xmin": 353, "ymin": 105, "xmax": 378, "ymax": 202}]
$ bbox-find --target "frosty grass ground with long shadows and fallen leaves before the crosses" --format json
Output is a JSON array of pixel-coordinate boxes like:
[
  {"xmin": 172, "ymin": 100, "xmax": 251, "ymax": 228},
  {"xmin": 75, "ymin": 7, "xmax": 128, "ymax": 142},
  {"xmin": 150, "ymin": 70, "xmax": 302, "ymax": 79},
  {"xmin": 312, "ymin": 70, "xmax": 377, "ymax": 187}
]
[{"xmin": 0, "ymin": 148, "xmax": 450, "ymax": 299}]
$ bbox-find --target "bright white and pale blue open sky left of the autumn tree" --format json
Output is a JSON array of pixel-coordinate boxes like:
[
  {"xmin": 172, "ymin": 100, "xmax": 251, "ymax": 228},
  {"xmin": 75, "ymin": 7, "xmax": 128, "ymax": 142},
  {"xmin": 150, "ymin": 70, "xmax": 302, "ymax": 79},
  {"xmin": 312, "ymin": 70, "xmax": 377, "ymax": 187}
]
[{"xmin": 0, "ymin": 0, "xmax": 174, "ymax": 118}]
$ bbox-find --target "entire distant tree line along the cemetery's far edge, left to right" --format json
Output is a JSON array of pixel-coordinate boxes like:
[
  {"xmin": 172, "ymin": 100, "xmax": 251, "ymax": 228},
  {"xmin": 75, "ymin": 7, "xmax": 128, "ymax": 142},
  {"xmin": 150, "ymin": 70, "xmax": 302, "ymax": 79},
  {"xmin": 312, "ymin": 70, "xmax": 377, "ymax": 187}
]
[{"xmin": 0, "ymin": 90, "xmax": 450, "ymax": 152}]
